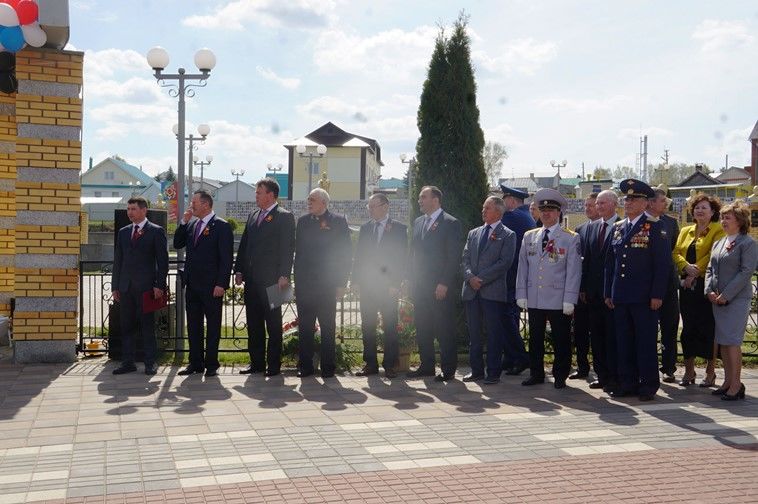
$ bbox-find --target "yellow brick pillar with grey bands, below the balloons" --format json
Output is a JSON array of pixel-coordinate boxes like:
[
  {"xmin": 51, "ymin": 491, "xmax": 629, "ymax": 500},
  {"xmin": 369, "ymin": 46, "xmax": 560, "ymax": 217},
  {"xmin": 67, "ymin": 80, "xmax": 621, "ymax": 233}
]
[{"xmin": 10, "ymin": 49, "xmax": 83, "ymax": 362}]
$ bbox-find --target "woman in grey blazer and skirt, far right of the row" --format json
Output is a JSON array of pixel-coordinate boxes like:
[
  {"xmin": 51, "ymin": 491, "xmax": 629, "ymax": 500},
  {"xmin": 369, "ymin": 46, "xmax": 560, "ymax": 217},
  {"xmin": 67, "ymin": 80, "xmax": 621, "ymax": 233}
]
[{"xmin": 705, "ymin": 201, "xmax": 758, "ymax": 401}]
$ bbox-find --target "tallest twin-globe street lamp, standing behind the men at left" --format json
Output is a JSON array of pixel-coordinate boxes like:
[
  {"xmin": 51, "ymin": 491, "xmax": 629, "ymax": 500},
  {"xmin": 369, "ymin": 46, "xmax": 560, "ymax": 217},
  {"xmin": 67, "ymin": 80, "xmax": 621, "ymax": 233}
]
[{"xmin": 147, "ymin": 47, "xmax": 216, "ymax": 350}]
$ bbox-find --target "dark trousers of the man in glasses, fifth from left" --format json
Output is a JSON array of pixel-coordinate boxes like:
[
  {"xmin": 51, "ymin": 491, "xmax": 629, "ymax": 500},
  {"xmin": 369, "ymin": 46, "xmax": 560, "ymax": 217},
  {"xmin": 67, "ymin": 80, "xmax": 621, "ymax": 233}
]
[{"xmin": 361, "ymin": 289, "xmax": 400, "ymax": 369}]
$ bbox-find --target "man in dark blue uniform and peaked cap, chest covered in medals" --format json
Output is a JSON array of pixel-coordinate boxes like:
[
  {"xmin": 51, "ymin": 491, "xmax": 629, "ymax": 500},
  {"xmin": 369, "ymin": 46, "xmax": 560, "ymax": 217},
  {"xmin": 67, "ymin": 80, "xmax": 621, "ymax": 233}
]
[{"xmin": 605, "ymin": 179, "xmax": 671, "ymax": 401}]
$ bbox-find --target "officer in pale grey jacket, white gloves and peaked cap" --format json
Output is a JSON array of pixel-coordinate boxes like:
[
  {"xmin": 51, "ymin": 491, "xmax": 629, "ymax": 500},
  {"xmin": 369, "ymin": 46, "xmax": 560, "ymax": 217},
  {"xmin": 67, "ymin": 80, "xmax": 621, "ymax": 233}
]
[{"xmin": 516, "ymin": 189, "xmax": 582, "ymax": 388}]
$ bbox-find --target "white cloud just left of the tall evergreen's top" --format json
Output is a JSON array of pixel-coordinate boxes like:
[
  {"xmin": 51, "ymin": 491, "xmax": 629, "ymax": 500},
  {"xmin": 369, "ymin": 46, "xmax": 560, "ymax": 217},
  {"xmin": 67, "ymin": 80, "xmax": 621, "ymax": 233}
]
[{"xmin": 313, "ymin": 26, "xmax": 438, "ymax": 78}]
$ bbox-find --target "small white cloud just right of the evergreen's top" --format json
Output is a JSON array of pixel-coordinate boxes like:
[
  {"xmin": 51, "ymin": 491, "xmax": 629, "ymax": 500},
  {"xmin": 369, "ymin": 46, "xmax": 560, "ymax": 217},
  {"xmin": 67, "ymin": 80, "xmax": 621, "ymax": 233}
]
[{"xmin": 478, "ymin": 38, "xmax": 558, "ymax": 75}]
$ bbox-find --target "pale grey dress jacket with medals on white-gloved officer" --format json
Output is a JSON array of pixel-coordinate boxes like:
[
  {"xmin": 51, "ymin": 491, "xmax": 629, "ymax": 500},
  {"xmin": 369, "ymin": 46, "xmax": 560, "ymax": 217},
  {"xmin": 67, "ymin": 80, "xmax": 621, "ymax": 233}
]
[{"xmin": 516, "ymin": 227, "xmax": 582, "ymax": 310}]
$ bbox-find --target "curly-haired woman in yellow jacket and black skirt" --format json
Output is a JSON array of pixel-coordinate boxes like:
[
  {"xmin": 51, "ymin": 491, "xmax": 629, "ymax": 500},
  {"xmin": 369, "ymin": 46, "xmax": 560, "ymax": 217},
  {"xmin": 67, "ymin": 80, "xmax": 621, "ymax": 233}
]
[{"xmin": 673, "ymin": 194, "xmax": 724, "ymax": 387}]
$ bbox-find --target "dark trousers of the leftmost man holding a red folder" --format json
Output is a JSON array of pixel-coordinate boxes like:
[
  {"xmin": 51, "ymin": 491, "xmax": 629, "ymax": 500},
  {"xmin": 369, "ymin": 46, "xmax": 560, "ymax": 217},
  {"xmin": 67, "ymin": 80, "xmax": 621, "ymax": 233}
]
[{"xmin": 119, "ymin": 286, "xmax": 157, "ymax": 366}]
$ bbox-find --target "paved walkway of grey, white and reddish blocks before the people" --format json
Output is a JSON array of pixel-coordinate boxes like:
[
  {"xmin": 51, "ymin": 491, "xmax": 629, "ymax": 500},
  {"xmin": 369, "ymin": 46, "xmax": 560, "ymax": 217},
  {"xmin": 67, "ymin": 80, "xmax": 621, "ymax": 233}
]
[{"xmin": 0, "ymin": 360, "xmax": 758, "ymax": 503}]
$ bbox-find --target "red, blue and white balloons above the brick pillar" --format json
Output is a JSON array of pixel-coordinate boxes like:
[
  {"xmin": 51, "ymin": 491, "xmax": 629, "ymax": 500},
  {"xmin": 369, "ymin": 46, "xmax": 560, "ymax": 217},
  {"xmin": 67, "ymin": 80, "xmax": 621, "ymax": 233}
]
[{"xmin": 0, "ymin": 0, "xmax": 47, "ymax": 53}]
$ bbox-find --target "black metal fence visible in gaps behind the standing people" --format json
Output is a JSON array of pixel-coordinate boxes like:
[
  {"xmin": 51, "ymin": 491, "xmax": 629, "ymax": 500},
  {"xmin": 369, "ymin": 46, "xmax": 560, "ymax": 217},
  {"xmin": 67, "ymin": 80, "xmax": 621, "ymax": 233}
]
[{"xmin": 77, "ymin": 261, "xmax": 758, "ymax": 357}]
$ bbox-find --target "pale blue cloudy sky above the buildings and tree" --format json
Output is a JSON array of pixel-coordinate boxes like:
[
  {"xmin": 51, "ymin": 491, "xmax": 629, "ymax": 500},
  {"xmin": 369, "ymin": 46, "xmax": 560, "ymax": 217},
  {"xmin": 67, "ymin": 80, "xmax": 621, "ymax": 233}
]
[{"xmin": 69, "ymin": 0, "xmax": 758, "ymax": 181}]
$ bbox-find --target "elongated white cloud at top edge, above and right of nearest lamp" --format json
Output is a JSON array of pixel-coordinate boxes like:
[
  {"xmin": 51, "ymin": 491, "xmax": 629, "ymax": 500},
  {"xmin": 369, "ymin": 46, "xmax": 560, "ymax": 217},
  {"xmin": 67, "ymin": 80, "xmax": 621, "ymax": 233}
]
[{"xmin": 182, "ymin": 0, "xmax": 336, "ymax": 30}]
